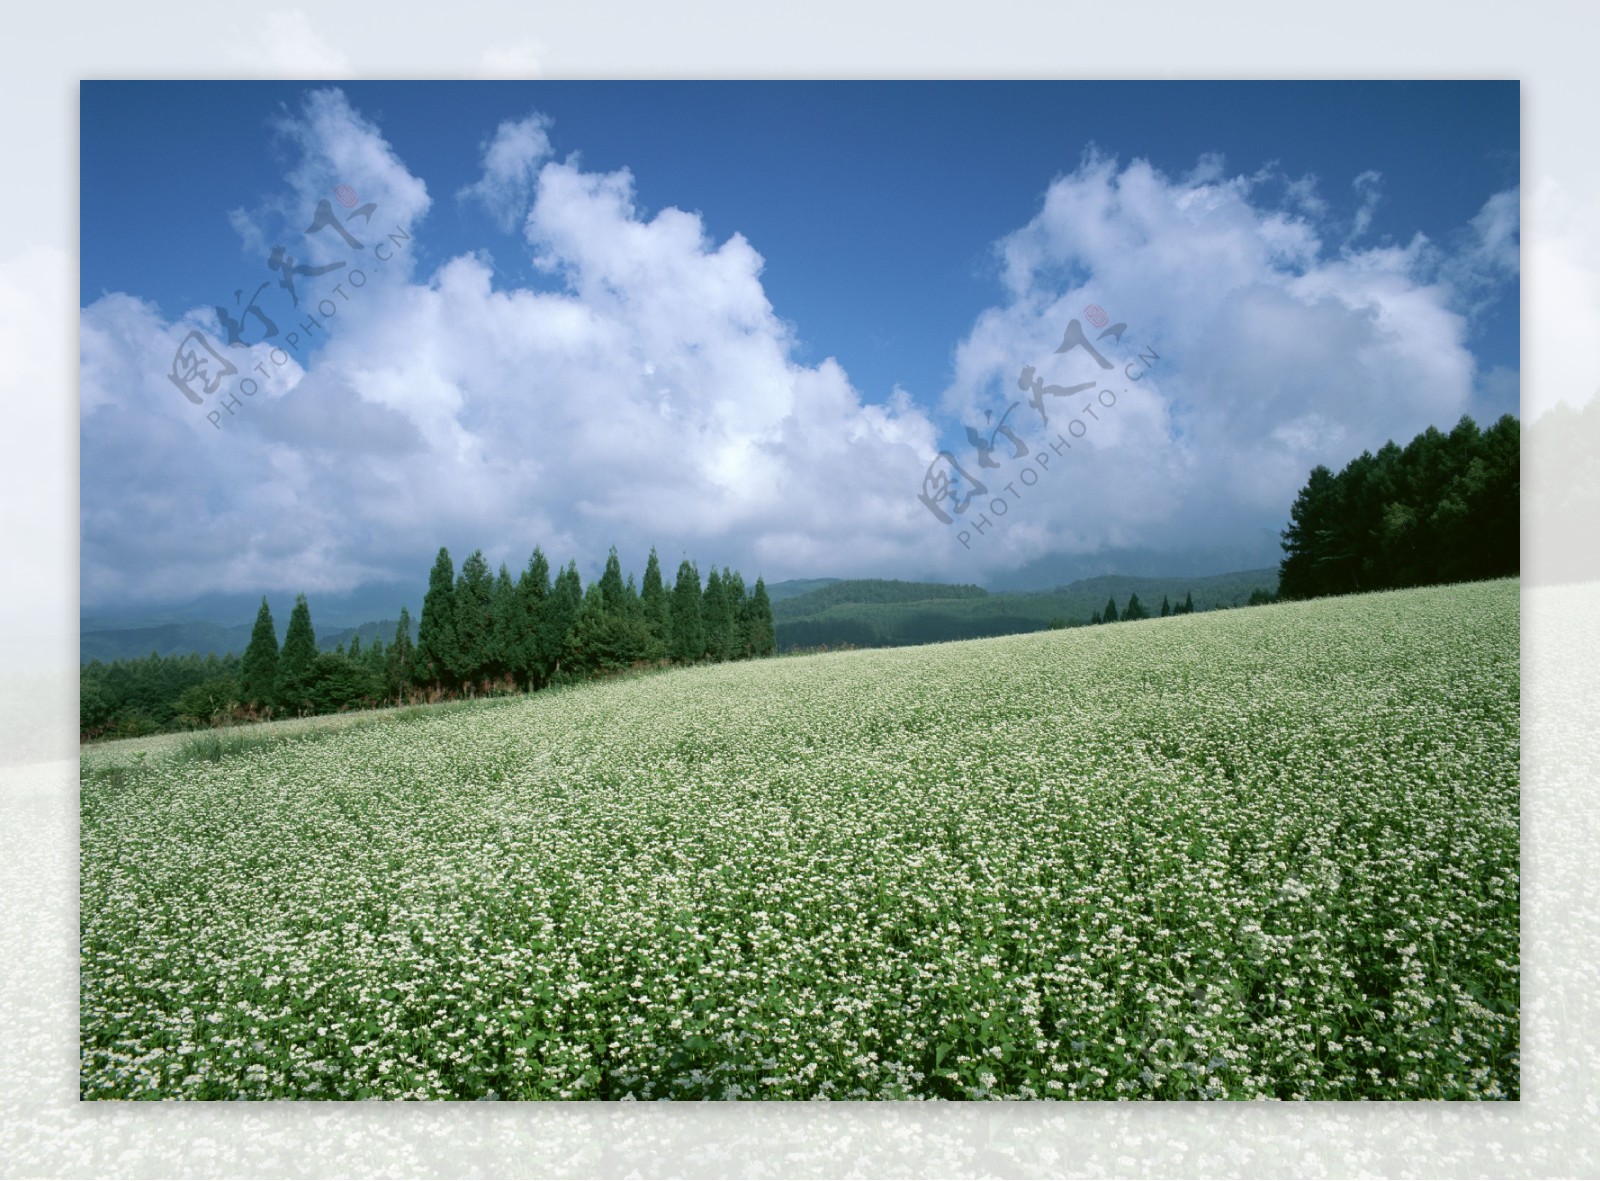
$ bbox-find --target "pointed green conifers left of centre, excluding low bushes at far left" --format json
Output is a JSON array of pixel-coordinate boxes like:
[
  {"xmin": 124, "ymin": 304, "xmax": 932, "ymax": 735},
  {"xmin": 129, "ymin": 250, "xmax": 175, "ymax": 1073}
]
[{"xmin": 238, "ymin": 546, "xmax": 778, "ymax": 714}]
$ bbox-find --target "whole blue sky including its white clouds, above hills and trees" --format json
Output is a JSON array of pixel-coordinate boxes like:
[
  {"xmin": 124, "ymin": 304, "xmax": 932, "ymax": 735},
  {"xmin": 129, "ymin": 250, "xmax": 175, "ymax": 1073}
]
[{"xmin": 80, "ymin": 82, "xmax": 1520, "ymax": 610}]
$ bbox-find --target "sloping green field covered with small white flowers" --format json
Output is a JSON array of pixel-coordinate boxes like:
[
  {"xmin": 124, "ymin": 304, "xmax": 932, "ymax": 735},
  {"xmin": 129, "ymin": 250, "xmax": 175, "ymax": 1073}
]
[{"xmin": 80, "ymin": 581, "xmax": 1520, "ymax": 1099}]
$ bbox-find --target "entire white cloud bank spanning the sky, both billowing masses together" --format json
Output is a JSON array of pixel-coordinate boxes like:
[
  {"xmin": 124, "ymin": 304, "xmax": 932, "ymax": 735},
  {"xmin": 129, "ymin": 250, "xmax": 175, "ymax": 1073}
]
[{"xmin": 82, "ymin": 91, "xmax": 1506, "ymax": 607}]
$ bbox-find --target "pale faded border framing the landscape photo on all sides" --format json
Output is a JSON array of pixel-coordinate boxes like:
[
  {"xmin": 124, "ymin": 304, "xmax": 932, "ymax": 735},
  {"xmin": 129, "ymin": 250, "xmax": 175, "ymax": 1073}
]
[{"xmin": 0, "ymin": 0, "xmax": 1600, "ymax": 1176}]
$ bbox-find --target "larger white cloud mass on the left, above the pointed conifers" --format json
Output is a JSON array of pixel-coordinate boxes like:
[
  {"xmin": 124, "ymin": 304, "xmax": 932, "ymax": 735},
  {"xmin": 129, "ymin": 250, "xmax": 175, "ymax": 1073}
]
[{"xmin": 82, "ymin": 93, "xmax": 934, "ymax": 605}]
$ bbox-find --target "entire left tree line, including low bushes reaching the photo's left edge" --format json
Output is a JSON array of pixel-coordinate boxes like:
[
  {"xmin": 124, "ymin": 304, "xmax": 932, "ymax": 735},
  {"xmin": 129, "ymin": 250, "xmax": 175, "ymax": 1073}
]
[{"xmin": 80, "ymin": 546, "xmax": 776, "ymax": 738}]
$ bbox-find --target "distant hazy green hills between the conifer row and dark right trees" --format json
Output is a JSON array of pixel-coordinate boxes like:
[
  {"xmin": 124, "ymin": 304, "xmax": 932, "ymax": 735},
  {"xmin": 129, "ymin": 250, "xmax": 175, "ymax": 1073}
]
[{"xmin": 773, "ymin": 568, "xmax": 1278, "ymax": 651}]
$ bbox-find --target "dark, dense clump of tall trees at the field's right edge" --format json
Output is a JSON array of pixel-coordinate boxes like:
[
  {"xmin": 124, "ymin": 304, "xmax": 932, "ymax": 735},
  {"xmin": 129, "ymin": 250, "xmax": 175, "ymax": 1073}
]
[{"xmin": 1278, "ymin": 414, "xmax": 1522, "ymax": 599}]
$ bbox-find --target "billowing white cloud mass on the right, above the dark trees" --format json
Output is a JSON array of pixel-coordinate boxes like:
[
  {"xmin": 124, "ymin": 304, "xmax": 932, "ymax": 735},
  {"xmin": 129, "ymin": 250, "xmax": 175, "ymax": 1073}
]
[{"xmin": 942, "ymin": 152, "xmax": 1515, "ymax": 563}]
